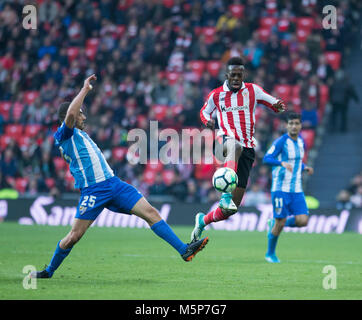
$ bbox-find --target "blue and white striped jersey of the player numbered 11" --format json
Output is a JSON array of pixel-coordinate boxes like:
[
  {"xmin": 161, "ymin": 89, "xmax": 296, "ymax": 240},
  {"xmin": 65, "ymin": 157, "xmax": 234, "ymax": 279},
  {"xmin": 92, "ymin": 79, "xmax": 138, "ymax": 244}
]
[{"xmin": 263, "ymin": 133, "xmax": 305, "ymax": 192}]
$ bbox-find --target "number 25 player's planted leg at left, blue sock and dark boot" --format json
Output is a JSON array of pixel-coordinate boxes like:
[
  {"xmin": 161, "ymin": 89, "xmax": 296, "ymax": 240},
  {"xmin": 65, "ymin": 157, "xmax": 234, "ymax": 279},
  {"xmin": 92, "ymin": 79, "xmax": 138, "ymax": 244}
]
[{"xmin": 30, "ymin": 218, "xmax": 93, "ymax": 278}]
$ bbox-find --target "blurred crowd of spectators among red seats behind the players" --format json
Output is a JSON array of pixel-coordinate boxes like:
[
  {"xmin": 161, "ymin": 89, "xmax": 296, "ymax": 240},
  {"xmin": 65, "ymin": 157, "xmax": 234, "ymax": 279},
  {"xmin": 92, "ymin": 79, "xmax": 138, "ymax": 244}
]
[{"xmin": 0, "ymin": 0, "xmax": 361, "ymax": 205}]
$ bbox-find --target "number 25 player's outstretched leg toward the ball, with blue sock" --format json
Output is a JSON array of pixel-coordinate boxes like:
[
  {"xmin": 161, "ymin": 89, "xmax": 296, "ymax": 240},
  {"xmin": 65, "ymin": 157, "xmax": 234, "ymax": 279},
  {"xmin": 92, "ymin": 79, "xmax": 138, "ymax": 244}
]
[{"xmin": 130, "ymin": 197, "xmax": 209, "ymax": 261}]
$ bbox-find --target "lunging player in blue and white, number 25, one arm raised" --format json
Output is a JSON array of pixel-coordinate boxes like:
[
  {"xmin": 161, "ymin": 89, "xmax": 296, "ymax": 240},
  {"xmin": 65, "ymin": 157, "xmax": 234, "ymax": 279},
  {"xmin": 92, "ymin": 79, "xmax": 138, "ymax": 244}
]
[{"xmin": 31, "ymin": 75, "xmax": 208, "ymax": 278}]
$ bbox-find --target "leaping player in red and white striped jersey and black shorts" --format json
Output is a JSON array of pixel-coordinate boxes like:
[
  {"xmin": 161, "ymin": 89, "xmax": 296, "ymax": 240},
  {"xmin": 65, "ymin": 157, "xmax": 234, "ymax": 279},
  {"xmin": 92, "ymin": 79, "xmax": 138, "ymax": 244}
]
[{"xmin": 191, "ymin": 57, "xmax": 285, "ymax": 240}]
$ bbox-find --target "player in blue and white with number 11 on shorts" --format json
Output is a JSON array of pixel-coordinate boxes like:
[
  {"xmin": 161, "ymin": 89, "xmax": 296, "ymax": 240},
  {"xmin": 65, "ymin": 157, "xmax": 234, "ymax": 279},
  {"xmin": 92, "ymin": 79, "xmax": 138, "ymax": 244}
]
[{"xmin": 263, "ymin": 113, "xmax": 313, "ymax": 263}]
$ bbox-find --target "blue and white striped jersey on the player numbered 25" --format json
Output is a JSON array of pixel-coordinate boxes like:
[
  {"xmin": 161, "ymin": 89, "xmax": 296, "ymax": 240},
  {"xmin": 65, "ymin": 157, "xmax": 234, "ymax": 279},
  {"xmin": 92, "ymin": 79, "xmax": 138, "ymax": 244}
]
[{"xmin": 54, "ymin": 122, "xmax": 114, "ymax": 189}]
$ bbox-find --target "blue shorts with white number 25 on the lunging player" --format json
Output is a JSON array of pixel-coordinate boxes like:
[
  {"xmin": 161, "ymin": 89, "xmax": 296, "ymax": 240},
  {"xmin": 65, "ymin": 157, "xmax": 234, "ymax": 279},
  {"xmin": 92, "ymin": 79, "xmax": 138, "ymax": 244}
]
[{"xmin": 75, "ymin": 176, "xmax": 143, "ymax": 220}]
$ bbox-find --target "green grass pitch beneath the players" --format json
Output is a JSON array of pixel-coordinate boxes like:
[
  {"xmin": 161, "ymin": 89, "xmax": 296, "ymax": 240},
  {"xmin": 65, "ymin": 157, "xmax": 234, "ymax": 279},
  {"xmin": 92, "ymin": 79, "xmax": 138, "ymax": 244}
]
[{"xmin": 0, "ymin": 222, "xmax": 362, "ymax": 300}]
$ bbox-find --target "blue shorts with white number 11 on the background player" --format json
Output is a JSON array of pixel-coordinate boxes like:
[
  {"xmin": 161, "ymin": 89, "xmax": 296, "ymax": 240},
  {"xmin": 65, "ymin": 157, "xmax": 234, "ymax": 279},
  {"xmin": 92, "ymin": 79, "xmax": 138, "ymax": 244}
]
[{"xmin": 271, "ymin": 191, "xmax": 309, "ymax": 219}]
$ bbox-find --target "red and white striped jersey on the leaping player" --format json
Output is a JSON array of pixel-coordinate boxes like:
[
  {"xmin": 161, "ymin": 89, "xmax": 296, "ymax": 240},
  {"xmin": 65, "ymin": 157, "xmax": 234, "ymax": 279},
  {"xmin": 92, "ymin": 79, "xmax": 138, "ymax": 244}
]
[{"xmin": 200, "ymin": 81, "xmax": 278, "ymax": 148}]
